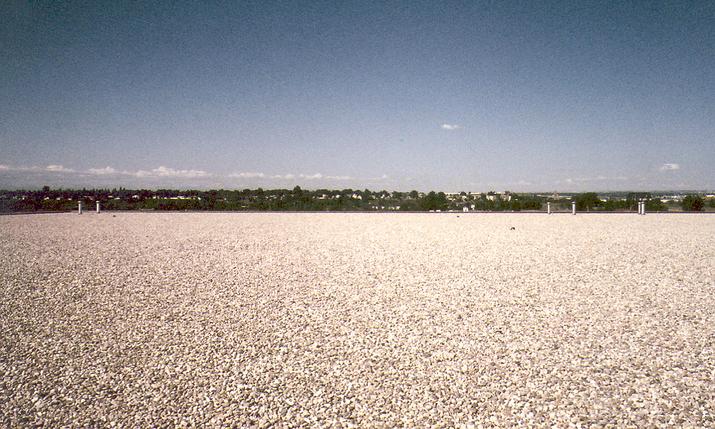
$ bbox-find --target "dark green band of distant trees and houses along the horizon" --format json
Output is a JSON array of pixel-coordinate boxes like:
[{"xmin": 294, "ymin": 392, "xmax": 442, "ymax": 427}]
[{"xmin": 0, "ymin": 186, "xmax": 715, "ymax": 212}]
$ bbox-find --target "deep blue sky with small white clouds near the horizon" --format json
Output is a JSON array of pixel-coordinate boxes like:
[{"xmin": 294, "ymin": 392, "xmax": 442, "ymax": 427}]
[{"xmin": 0, "ymin": 0, "xmax": 715, "ymax": 192}]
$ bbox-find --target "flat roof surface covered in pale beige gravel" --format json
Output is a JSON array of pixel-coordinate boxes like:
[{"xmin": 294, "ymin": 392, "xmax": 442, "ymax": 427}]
[{"xmin": 0, "ymin": 212, "xmax": 715, "ymax": 427}]
